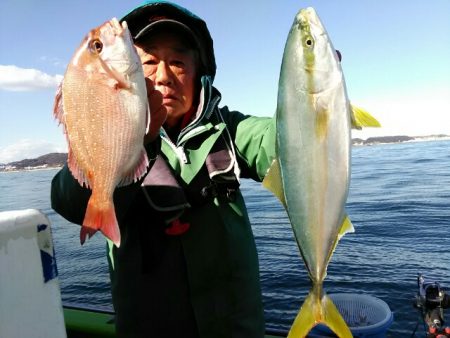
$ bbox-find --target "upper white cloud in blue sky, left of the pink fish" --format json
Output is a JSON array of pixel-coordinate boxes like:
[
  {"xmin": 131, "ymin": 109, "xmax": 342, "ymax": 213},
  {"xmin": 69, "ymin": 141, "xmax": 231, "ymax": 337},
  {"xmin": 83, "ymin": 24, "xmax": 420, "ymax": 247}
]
[{"xmin": 0, "ymin": 65, "xmax": 63, "ymax": 91}]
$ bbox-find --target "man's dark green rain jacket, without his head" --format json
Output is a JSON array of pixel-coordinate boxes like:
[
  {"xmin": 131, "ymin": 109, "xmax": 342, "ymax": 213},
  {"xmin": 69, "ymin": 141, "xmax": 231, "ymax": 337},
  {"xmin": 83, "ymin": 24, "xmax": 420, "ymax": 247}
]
[{"xmin": 51, "ymin": 76, "xmax": 275, "ymax": 338}]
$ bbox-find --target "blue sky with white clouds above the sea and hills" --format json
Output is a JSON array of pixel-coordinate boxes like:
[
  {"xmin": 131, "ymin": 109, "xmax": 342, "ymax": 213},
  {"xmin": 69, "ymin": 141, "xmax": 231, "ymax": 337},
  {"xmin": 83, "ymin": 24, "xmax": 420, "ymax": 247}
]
[{"xmin": 0, "ymin": 0, "xmax": 450, "ymax": 163}]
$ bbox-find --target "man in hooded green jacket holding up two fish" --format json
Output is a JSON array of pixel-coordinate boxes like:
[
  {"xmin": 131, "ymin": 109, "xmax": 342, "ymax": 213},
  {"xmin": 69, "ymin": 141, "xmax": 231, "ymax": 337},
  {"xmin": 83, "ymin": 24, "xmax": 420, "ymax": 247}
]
[{"xmin": 51, "ymin": 1, "xmax": 275, "ymax": 338}]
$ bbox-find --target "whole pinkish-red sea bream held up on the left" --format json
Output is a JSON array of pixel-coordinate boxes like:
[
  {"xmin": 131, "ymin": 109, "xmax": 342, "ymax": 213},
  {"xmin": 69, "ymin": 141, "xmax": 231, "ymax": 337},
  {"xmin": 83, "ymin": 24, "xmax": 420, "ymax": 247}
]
[{"xmin": 54, "ymin": 18, "xmax": 150, "ymax": 246}]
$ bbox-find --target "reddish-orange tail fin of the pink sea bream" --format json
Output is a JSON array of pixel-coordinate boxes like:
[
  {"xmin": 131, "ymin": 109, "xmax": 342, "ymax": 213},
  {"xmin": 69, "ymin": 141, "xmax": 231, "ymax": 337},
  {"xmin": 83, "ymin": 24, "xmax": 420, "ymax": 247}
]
[{"xmin": 80, "ymin": 193, "xmax": 120, "ymax": 247}]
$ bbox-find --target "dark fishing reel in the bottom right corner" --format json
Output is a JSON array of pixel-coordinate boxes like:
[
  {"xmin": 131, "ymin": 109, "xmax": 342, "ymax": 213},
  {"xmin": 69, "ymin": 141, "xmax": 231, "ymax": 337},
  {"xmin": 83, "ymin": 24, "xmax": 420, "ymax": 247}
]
[{"xmin": 414, "ymin": 274, "xmax": 450, "ymax": 338}]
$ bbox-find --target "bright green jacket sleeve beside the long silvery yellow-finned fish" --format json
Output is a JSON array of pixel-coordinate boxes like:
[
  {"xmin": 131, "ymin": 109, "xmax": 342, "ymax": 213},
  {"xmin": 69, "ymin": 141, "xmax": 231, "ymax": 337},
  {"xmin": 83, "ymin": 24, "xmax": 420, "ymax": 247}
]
[{"xmin": 220, "ymin": 107, "xmax": 276, "ymax": 182}]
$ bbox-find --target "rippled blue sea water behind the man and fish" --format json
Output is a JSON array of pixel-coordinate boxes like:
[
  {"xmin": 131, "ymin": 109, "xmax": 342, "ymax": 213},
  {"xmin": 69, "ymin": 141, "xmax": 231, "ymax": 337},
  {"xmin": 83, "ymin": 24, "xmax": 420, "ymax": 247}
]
[{"xmin": 0, "ymin": 141, "xmax": 450, "ymax": 337}]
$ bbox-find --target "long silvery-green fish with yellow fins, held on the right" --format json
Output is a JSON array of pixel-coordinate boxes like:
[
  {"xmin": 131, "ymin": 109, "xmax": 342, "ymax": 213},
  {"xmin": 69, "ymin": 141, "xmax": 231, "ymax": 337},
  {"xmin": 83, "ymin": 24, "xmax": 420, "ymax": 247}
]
[{"xmin": 263, "ymin": 8, "xmax": 379, "ymax": 338}]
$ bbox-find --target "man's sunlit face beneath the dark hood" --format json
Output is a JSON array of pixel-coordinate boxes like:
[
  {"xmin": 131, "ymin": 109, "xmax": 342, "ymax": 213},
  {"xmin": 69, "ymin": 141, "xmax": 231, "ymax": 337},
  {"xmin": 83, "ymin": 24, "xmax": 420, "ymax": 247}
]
[{"xmin": 136, "ymin": 33, "xmax": 197, "ymax": 127}]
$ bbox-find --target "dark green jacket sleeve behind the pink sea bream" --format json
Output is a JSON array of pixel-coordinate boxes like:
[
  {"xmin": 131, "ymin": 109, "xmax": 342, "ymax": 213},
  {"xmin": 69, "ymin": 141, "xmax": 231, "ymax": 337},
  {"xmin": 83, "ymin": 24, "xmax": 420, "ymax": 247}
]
[{"xmin": 50, "ymin": 138, "xmax": 161, "ymax": 225}]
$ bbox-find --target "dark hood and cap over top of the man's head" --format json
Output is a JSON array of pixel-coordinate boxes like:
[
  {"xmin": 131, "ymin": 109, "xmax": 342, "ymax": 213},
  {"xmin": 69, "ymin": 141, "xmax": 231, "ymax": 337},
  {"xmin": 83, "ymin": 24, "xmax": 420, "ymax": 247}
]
[{"xmin": 120, "ymin": 1, "xmax": 216, "ymax": 78}]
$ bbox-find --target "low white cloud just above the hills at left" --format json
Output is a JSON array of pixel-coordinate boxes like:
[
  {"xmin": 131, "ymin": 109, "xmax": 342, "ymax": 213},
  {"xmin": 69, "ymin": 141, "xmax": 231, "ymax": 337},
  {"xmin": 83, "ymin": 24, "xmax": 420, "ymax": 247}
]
[{"xmin": 0, "ymin": 139, "xmax": 67, "ymax": 164}]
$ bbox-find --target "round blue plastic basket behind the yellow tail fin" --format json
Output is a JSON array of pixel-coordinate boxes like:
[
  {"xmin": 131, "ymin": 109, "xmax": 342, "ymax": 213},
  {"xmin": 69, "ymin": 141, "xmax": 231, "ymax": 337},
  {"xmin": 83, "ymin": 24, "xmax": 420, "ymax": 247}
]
[{"xmin": 308, "ymin": 293, "xmax": 394, "ymax": 338}]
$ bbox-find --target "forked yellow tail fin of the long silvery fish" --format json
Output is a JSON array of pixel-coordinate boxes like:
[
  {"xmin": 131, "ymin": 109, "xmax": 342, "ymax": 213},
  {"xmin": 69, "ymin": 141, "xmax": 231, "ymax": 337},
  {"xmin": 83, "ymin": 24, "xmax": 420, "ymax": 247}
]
[{"xmin": 288, "ymin": 286, "xmax": 353, "ymax": 338}]
